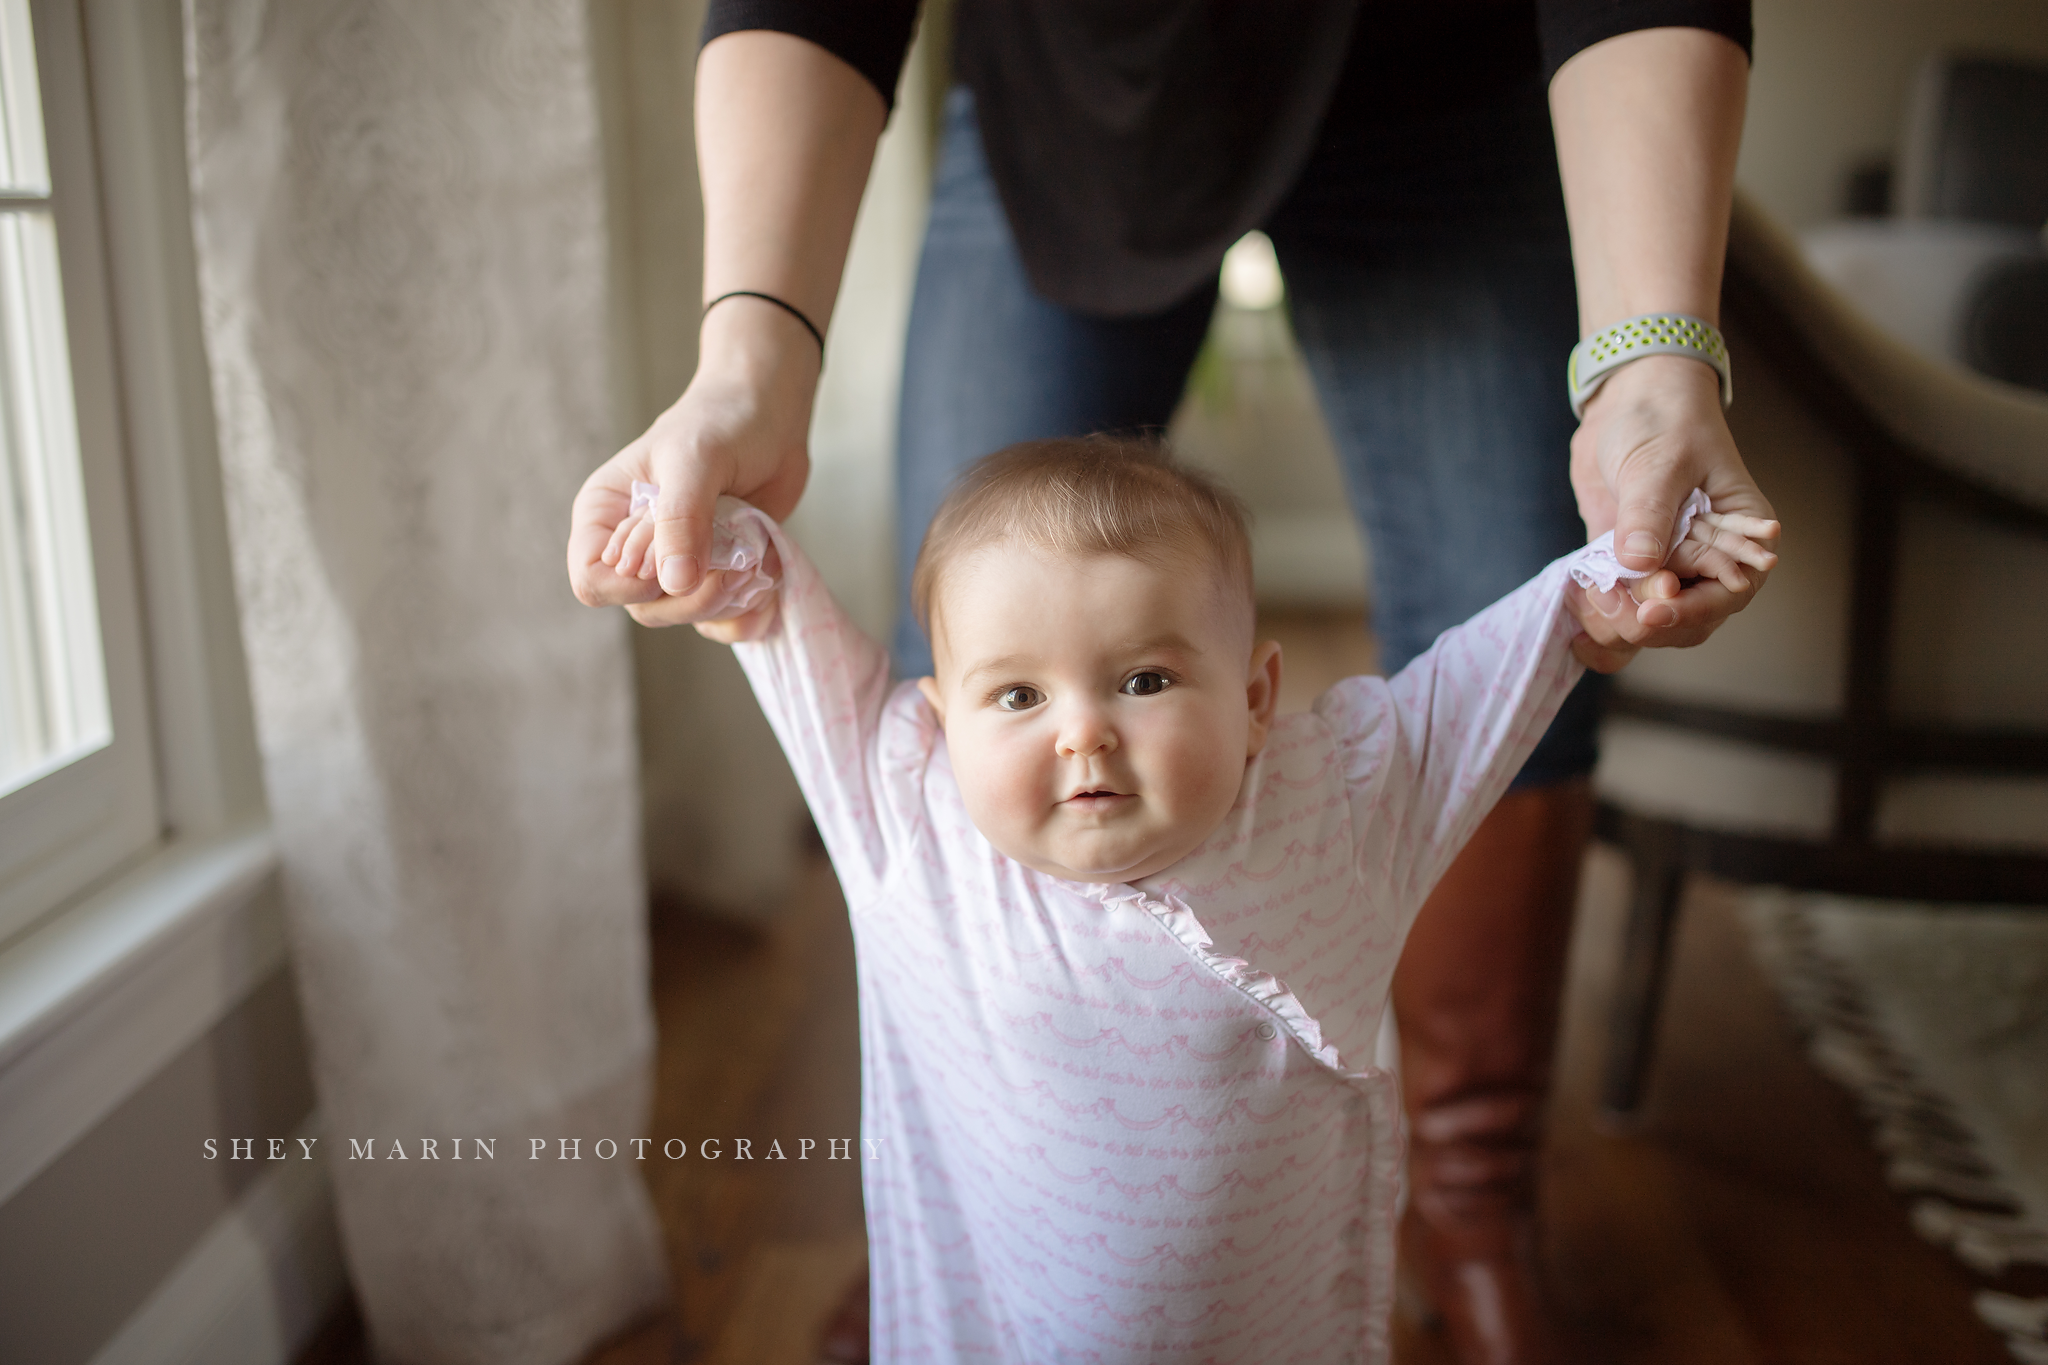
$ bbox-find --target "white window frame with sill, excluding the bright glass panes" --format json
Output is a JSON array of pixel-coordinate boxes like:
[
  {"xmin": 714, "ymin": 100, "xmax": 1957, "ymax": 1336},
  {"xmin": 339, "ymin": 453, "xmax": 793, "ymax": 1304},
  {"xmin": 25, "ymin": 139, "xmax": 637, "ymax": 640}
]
[{"xmin": 0, "ymin": 0, "xmax": 285, "ymax": 1203}]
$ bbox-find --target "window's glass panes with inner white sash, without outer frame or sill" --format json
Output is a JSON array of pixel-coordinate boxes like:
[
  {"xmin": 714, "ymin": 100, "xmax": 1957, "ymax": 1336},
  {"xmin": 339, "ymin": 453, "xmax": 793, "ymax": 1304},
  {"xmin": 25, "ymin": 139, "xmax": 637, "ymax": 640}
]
[{"xmin": 0, "ymin": 0, "xmax": 158, "ymax": 939}]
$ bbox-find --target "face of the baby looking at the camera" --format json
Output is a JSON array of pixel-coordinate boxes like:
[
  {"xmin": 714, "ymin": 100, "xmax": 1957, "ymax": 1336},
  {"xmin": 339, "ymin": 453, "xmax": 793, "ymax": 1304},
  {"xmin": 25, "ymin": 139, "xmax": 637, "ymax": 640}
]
[{"xmin": 918, "ymin": 542, "xmax": 1280, "ymax": 882}]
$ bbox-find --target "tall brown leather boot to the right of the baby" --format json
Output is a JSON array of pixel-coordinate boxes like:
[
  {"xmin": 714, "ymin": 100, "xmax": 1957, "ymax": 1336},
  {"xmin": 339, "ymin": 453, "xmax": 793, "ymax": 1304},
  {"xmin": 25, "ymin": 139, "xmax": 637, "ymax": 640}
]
[{"xmin": 1393, "ymin": 782, "xmax": 1593, "ymax": 1365}]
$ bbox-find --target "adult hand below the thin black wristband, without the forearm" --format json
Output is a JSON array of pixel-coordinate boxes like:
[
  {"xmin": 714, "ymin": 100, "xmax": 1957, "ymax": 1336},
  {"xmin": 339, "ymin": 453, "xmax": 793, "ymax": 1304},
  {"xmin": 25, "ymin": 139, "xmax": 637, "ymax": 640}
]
[{"xmin": 569, "ymin": 299, "xmax": 819, "ymax": 626}]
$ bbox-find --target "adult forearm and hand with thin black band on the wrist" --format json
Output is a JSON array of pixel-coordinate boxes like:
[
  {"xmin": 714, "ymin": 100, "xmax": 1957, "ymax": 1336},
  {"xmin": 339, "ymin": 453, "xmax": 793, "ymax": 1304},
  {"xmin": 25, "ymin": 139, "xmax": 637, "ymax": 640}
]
[{"xmin": 569, "ymin": 29, "xmax": 889, "ymax": 626}]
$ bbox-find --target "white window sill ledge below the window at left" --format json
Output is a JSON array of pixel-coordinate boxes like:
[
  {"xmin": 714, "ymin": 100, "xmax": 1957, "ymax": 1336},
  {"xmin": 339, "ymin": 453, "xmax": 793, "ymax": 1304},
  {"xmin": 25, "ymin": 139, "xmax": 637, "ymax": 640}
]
[{"xmin": 0, "ymin": 821, "xmax": 285, "ymax": 1203}]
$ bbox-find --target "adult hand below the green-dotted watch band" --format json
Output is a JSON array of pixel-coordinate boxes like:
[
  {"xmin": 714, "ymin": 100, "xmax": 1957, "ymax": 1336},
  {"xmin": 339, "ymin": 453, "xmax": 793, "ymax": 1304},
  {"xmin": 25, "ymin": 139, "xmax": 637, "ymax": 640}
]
[{"xmin": 1571, "ymin": 356, "xmax": 1776, "ymax": 650}]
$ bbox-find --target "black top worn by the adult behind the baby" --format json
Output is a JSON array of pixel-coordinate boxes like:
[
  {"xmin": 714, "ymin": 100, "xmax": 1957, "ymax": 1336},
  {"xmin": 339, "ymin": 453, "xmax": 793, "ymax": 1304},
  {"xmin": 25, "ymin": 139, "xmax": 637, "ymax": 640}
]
[{"xmin": 702, "ymin": 0, "xmax": 1751, "ymax": 315}]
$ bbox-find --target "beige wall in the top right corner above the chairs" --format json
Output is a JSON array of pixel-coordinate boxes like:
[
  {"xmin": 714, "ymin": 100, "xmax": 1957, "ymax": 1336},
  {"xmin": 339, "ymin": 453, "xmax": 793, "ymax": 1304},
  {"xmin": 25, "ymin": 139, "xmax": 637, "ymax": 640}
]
[{"xmin": 1737, "ymin": 0, "xmax": 2048, "ymax": 229}]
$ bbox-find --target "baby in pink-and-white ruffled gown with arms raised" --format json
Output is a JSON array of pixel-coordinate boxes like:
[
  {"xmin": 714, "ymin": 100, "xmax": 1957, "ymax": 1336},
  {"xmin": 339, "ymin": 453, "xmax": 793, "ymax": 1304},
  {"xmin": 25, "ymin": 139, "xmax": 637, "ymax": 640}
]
[{"xmin": 614, "ymin": 438, "xmax": 1778, "ymax": 1365}]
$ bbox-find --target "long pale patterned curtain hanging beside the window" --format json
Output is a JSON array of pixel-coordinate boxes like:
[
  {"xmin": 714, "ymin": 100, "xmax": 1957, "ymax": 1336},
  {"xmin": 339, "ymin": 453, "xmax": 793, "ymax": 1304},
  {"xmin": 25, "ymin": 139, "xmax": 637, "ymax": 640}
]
[{"xmin": 186, "ymin": 0, "xmax": 664, "ymax": 1365}]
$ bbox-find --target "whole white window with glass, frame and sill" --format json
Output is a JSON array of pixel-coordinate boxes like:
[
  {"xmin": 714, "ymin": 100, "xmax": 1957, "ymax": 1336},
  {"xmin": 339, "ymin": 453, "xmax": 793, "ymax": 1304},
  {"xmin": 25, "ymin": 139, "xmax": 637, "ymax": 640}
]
[{"xmin": 0, "ymin": 0, "xmax": 285, "ymax": 1203}]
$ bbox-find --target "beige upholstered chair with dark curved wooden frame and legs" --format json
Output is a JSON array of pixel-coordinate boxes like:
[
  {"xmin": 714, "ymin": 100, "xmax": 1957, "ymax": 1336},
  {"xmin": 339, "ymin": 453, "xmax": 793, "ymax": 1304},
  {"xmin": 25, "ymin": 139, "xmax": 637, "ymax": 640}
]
[{"xmin": 1595, "ymin": 201, "xmax": 2048, "ymax": 1115}]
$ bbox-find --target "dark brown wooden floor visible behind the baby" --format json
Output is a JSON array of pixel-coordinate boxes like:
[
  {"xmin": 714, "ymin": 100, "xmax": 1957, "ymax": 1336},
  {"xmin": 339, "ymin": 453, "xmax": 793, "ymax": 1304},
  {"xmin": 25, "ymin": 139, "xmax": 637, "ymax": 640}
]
[{"xmin": 301, "ymin": 616, "xmax": 2011, "ymax": 1365}]
